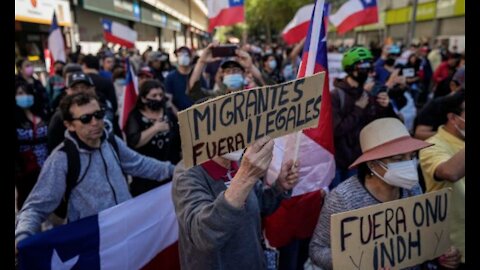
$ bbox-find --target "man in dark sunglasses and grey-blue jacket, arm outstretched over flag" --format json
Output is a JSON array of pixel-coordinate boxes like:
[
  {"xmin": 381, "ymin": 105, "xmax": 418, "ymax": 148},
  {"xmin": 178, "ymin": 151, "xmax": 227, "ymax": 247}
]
[{"xmin": 15, "ymin": 93, "xmax": 174, "ymax": 253}]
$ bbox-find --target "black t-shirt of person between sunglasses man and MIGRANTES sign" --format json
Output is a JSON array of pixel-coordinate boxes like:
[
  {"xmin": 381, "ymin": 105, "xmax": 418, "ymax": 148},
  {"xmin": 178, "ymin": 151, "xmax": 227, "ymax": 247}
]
[{"xmin": 125, "ymin": 108, "xmax": 181, "ymax": 164}]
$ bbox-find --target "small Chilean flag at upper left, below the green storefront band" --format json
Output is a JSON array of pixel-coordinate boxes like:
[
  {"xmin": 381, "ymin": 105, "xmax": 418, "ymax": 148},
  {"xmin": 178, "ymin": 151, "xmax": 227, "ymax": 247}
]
[{"xmin": 102, "ymin": 19, "xmax": 137, "ymax": 48}]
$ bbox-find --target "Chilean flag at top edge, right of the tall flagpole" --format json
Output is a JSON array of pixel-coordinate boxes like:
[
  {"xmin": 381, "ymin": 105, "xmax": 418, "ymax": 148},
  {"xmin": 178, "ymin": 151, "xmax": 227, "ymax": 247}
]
[{"xmin": 330, "ymin": 0, "xmax": 378, "ymax": 34}]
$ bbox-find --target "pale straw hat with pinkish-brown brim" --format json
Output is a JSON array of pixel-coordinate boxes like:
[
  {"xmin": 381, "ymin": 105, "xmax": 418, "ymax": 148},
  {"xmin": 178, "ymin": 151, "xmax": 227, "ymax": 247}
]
[{"xmin": 349, "ymin": 118, "xmax": 433, "ymax": 168}]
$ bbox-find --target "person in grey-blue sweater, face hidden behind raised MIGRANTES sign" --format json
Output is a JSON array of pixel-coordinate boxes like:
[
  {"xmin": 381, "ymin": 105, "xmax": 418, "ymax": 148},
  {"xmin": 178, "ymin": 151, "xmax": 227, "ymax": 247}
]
[{"xmin": 172, "ymin": 137, "xmax": 298, "ymax": 270}]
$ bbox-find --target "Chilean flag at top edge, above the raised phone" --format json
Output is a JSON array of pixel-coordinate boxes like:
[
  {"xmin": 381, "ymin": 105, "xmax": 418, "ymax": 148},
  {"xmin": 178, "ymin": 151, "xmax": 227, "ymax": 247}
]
[{"xmin": 207, "ymin": 0, "xmax": 245, "ymax": 32}]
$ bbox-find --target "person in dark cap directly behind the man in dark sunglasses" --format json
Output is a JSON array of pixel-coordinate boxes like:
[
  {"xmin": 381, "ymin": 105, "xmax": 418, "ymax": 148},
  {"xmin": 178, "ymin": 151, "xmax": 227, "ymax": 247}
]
[{"xmin": 47, "ymin": 72, "xmax": 114, "ymax": 153}]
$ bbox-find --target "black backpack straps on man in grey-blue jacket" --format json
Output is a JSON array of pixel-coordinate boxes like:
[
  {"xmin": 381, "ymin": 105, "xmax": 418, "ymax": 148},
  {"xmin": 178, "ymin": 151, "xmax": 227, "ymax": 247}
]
[{"xmin": 54, "ymin": 135, "xmax": 120, "ymax": 219}]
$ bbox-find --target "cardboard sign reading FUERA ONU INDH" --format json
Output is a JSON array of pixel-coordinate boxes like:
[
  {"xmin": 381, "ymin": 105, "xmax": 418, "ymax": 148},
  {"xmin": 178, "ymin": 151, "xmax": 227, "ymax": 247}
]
[{"xmin": 330, "ymin": 189, "xmax": 451, "ymax": 270}]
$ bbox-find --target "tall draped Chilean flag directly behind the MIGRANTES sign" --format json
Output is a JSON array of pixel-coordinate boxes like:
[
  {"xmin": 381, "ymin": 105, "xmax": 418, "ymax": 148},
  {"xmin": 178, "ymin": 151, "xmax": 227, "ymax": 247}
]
[{"xmin": 264, "ymin": 0, "xmax": 335, "ymax": 247}]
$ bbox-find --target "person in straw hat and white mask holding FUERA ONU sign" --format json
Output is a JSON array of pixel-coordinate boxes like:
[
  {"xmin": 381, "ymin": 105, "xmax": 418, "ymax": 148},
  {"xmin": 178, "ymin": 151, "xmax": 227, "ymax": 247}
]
[{"xmin": 310, "ymin": 118, "xmax": 460, "ymax": 269}]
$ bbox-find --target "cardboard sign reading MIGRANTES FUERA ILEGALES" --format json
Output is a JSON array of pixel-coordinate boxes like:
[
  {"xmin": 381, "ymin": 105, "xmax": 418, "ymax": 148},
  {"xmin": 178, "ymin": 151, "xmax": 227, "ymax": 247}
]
[{"xmin": 178, "ymin": 72, "xmax": 325, "ymax": 169}]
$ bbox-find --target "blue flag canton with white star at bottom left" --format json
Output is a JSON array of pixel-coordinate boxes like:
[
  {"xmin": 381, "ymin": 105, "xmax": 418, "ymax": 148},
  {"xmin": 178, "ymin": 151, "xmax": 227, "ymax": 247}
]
[{"xmin": 18, "ymin": 215, "xmax": 100, "ymax": 270}]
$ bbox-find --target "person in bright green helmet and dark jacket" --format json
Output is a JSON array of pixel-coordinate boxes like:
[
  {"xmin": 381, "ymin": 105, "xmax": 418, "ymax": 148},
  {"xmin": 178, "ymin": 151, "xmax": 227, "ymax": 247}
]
[{"xmin": 330, "ymin": 47, "xmax": 397, "ymax": 188}]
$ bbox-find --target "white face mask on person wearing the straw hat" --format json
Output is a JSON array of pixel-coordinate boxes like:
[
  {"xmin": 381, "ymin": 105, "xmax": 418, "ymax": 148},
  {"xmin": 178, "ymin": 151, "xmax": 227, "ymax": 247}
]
[{"xmin": 370, "ymin": 159, "xmax": 418, "ymax": 189}]
